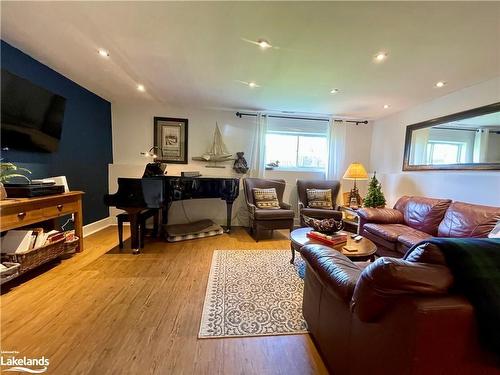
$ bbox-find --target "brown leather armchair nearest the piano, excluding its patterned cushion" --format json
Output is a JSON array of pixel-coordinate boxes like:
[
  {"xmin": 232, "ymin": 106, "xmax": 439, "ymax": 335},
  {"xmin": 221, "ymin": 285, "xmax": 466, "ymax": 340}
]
[{"xmin": 243, "ymin": 178, "xmax": 295, "ymax": 241}]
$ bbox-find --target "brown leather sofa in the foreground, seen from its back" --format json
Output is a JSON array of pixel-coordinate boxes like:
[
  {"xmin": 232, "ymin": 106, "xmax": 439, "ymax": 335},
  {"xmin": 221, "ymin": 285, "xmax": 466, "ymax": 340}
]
[{"xmin": 301, "ymin": 245, "xmax": 499, "ymax": 375}]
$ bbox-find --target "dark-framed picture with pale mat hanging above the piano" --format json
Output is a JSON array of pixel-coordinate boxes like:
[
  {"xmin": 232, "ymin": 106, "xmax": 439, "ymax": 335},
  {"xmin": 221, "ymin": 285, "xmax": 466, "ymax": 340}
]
[{"xmin": 154, "ymin": 117, "xmax": 188, "ymax": 164}]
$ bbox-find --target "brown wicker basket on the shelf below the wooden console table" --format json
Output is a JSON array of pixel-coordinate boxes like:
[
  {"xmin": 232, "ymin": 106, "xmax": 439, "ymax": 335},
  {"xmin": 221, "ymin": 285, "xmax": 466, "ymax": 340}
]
[{"xmin": 2, "ymin": 238, "xmax": 65, "ymax": 274}]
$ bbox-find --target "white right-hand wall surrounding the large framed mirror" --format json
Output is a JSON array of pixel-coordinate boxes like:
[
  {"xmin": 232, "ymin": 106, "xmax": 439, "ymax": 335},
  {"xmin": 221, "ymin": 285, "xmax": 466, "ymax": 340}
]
[{"xmin": 371, "ymin": 77, "xmax": 500, "ymax": 206}]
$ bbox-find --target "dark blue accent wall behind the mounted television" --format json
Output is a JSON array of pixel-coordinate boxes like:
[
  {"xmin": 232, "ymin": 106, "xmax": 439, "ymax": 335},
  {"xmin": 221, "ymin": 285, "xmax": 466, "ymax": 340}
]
[{"xmin": 1, "ymin": 41, "xmax": 113, "ymax": 224}]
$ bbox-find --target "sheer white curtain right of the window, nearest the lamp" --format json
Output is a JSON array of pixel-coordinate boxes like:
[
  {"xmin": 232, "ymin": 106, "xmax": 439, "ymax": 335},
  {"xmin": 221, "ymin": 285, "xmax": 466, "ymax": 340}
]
[{"xmin": 326, "ymin": 118, "xmax": 346, "ymax": 181}]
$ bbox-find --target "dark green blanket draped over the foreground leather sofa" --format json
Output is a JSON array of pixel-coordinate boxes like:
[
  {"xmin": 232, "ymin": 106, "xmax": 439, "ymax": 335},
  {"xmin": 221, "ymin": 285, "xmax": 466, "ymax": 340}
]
[{"xmin": 416, "ymin": 238, "xmax": 500, "ymax": 359}]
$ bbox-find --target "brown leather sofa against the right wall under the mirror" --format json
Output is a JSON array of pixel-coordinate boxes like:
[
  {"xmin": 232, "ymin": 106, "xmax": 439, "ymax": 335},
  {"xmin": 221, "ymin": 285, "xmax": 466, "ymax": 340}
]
[{"xmin": 357, "ymin": 196, "xmax": 500, "ymax": 258}]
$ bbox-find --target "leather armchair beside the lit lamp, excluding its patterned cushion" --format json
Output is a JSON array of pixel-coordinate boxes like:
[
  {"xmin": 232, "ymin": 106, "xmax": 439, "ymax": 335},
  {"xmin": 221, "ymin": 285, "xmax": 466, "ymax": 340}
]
[{"xmin": 297, "ymin": 180, "xmax": 342, "ymax": 227}]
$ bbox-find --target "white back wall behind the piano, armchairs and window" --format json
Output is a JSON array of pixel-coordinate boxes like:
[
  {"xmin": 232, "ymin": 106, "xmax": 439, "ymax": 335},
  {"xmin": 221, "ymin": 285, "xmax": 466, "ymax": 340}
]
[{"xmin": 109, "ymin": 102, "xmax": 371, "ymax": 225}]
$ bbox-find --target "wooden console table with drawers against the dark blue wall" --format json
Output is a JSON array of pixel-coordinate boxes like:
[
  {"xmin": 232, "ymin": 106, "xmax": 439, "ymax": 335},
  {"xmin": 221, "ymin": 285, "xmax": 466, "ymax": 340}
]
[{"xmin": 0, "ymin": 191, "xmax": 84, "ymax": 251}]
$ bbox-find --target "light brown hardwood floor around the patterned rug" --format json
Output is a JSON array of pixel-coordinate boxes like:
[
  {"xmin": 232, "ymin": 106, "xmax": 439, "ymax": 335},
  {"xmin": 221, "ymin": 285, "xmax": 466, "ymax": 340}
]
[{"xmin": 0, "ymin": 227, "xmax": 327, "ymax": 375}]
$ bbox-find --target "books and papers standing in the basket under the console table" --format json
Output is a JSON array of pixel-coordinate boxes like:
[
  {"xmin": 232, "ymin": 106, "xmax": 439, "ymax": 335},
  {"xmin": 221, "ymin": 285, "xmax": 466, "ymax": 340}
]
[{"xmin": 0, "ymin": 228, "xmax": 64, "ymax": 254}]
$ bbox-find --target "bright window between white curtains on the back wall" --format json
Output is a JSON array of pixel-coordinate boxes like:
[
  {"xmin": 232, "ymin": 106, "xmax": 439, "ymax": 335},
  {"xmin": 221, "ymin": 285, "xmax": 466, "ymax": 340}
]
[{"xmin": 266, "ymin": 118, "xmax": 328, "ymax": 169}]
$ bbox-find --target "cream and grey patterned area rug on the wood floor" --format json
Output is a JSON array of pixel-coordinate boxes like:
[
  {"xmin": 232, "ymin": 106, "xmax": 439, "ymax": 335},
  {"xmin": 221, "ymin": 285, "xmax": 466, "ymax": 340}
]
[{"xmin": 198, "ymin": 250, "xmax": 307, "ymax": 338}]
